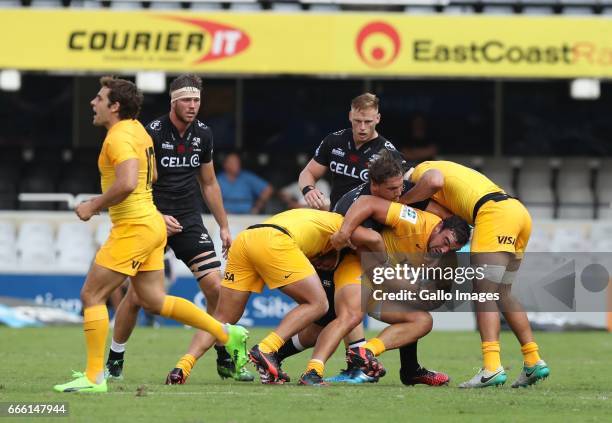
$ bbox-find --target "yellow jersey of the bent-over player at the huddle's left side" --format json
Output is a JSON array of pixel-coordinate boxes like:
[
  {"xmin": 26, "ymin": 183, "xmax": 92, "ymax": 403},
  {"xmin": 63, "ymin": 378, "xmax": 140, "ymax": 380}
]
[{"xmin": 263, "ymin": 208, "xmax": 344, "ymax": 258}]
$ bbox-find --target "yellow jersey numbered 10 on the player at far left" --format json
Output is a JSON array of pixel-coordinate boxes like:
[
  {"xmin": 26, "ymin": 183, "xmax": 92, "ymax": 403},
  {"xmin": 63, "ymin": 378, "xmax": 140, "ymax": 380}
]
[{"xmin": 98, "ymin": 119, "xmax": 157, "ymax": 223}]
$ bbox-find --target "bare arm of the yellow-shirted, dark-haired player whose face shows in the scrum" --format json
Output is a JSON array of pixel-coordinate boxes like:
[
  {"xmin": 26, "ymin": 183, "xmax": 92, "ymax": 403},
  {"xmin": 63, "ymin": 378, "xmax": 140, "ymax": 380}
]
[{"xmin": 331, "ymin": 195, "xmax": 391, "ymax": 249}]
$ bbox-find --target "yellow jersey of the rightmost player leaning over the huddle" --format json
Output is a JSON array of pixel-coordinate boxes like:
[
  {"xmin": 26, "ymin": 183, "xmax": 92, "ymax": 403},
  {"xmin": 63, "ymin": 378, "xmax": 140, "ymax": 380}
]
[{"xmin": 410, "ymin": 160, "xmax": 504, "ymax": 225}]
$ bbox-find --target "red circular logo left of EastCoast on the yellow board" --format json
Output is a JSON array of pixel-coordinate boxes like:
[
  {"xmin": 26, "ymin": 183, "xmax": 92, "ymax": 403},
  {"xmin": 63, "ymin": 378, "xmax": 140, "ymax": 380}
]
[{"xmin": 355, "ymin": 21, "xmax": 401, "ymax": 68}]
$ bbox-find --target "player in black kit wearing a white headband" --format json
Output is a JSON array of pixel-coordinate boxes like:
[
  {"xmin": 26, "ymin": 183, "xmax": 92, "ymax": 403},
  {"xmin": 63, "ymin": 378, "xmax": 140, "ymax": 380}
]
[{"xmin": 106, "ymin": 74, "xmax": 253, "ymax": 384}]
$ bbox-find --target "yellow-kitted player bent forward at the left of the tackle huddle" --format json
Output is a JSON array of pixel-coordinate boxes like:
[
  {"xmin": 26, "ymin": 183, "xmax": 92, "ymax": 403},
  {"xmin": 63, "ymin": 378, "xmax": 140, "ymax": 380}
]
[{"xmin": 163, "ymin": 209, "xmax": 384, "ymax": 384}]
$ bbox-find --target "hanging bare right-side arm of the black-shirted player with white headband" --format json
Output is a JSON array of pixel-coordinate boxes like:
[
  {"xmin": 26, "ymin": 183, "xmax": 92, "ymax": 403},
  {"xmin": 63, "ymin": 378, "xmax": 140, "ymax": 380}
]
[{"xmin": 197, "ymin": 160, "xmax": 232, "ymax": 255}]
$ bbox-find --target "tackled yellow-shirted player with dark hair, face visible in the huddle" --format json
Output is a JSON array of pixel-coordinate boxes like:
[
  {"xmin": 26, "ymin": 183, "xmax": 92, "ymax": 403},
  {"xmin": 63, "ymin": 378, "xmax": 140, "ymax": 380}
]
[{"xmin": 300, "ymin": 200, "xmax": 470, "ymax": 385}]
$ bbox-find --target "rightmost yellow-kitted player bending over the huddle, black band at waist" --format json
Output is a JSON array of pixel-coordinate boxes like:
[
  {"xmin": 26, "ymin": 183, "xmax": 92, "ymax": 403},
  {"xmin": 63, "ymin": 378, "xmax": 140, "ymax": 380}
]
[{"xmin": 402, "ymin": 161, "xmax": 550, "ymax": 388}]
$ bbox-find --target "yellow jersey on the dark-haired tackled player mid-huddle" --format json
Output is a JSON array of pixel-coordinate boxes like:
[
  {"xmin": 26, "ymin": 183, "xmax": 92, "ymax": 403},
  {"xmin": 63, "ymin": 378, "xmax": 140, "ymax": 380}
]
[{"xmin": 381, "ymin": 203, "xmax": 441, "ymax": 255}]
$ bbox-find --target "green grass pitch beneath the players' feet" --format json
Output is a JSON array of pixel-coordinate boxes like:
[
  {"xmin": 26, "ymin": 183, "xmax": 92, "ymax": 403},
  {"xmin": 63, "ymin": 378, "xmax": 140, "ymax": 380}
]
[{"xmin": 0, "ymin": 327, "xmax": 612, "ymax": 423}]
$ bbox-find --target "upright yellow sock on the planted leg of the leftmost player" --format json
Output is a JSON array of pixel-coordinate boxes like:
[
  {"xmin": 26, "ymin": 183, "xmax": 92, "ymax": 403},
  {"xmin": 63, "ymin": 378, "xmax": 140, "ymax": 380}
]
[{"xmin": 83, "ymin": 304, "xmax": 108, "ymax": 383}]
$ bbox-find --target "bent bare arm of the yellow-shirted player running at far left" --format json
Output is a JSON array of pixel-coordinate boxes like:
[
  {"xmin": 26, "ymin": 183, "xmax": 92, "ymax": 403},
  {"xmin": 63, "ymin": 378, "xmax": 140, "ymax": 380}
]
[{"xmin": 75, "ymin": 158, "xmax": 139, "ymax": 221}]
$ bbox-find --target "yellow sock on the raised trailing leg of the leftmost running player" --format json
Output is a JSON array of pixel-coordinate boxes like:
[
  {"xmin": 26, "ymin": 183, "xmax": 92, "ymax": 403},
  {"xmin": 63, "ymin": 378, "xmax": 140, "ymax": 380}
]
[{"xmin": 159, "ymin": 295, "xmax": 229, "ymax": 344}]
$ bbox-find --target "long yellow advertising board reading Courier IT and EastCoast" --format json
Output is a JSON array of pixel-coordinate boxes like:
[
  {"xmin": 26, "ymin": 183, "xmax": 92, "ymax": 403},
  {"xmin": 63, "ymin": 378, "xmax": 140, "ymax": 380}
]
[{"xmin": 0, "ymin": 9, "xmax": 612, "ymax": 78}]
